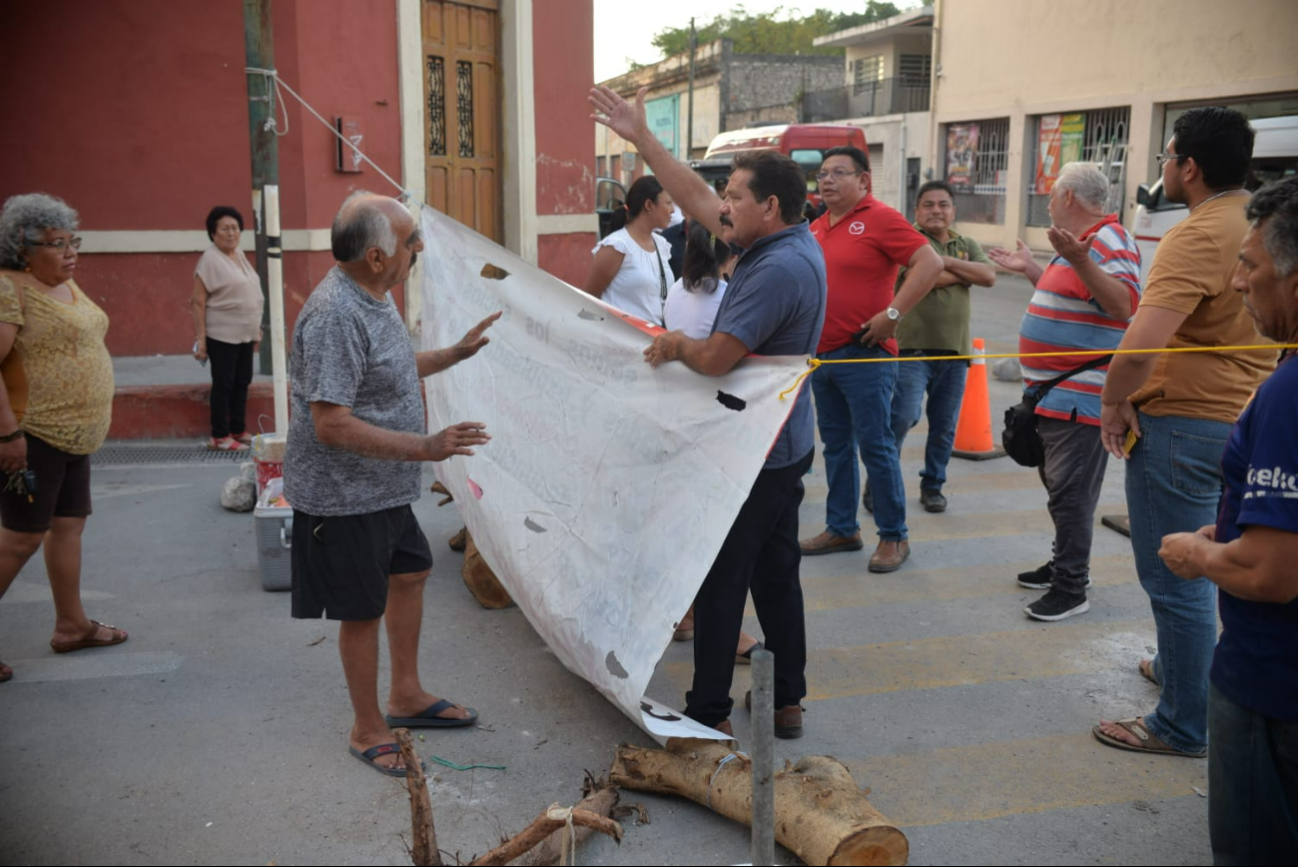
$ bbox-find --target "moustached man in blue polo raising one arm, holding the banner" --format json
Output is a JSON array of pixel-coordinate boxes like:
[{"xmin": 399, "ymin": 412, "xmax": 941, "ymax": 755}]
[{"xmin": 591, "ymin": 87, "xmax": 827, "ymax": 737}]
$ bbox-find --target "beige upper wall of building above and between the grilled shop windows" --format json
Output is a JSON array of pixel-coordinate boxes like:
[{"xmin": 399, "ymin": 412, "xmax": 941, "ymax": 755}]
[{"xmin": 929, "ymin": 0, "xmax": 1298, "ymax": 249}]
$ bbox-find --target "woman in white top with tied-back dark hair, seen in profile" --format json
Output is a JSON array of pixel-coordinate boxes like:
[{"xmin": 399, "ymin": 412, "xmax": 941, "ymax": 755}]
[{"xmin": 582, "ymin": 175, "xmax": 674, "ymax": 326}]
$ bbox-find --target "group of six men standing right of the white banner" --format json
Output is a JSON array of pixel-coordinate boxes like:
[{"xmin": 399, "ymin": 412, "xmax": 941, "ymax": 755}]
[{"xmin": 589, "ymin": 94, "xmax": 1298, "ymax": 863}]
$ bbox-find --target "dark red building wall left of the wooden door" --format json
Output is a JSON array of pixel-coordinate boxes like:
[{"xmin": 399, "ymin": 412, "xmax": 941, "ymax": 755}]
[{"xmin": 0, "ymin": 0, "xmax": 401, "ymax": 356}]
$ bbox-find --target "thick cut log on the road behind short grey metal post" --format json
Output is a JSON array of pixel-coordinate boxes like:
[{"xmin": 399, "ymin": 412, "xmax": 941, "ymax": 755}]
[{"xmin": 609, "ymin": 739, "xmax": 910, "ymax": 864}]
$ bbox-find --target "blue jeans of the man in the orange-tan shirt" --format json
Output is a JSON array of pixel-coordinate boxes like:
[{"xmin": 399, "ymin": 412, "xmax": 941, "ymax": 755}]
[{"xmin": 1127, "ymin": 413, "xmax": 1231, "ymax": 753}]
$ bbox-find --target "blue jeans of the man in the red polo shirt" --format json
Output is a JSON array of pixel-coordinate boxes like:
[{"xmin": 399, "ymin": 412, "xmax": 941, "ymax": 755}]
[{"xmin": 811, "ymin": 344, "xmax": 906, "ymax": 540}]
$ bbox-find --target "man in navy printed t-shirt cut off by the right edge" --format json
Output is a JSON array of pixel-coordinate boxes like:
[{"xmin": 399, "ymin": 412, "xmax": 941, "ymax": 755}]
[{"xmin": 1158, "ymin": 178, "xmax": 1298, "ymax": 864}]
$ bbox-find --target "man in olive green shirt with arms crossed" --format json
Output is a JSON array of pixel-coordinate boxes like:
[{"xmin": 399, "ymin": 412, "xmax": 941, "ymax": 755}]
[{"xmin": 892, "ymin": 180, "xmax": 996, "ymax": 511}]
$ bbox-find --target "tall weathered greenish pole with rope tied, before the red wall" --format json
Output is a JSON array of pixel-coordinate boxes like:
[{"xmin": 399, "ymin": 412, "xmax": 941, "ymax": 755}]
[{"xmin": 244, "ymin": 0, "xmax": 283, "ymax": 373}]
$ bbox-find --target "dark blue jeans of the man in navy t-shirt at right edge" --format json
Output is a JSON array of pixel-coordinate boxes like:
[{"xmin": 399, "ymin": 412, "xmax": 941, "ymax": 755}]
[{"xmin": 1208, "ymin": 687, "xmax": 1298, "ymax": 864}]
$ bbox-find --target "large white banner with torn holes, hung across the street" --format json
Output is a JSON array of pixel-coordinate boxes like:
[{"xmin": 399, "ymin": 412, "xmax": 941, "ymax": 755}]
[{"xmin": 421, "ymin": 208, "xmax": 806, "ymax": 740}]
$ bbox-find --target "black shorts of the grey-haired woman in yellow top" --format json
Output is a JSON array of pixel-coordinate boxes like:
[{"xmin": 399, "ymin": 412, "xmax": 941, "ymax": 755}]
[{"xmin": 0, "ymin": 434, "xmax": 91, "ymax": 533}]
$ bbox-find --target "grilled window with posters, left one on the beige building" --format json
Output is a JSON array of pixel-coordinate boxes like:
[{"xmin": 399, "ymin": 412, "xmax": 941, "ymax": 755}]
[{"xmin": 944, "ymin": 118, "xmax": 1010, "ymax": 225}]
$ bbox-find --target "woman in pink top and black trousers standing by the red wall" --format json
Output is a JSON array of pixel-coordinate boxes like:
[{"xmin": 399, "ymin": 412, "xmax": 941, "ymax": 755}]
[{"xmin": 190, "ymin": 205, "xmax": 263, "ymax": 452}]
